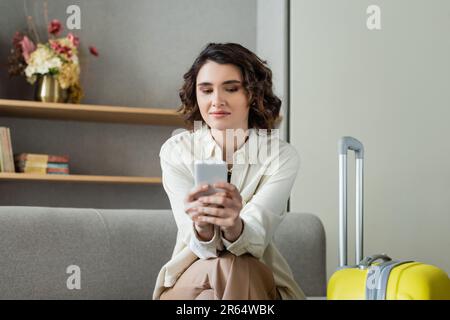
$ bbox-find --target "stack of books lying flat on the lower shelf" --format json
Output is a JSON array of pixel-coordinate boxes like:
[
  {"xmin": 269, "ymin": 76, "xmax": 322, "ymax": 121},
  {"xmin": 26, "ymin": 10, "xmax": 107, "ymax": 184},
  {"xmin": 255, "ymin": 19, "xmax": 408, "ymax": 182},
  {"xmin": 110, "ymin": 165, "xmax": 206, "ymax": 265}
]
[{"xmin": 14, "ymin": 153, "xmax": 69, "ymax": 174}]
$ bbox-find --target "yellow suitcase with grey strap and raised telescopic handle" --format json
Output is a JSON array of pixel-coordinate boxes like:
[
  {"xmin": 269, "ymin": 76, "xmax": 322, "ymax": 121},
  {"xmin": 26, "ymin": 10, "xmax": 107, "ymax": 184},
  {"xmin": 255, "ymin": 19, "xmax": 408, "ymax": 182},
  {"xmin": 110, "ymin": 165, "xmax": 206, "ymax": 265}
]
[{"xmin": 327, "ymin": 137, "xmax": 450, "ymax": 300}]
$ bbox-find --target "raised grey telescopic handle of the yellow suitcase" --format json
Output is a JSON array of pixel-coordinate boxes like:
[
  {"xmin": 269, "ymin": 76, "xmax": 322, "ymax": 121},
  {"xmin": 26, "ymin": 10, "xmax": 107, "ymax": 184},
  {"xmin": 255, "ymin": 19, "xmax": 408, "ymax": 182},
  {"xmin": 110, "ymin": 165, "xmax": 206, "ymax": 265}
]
[{"xmin": 338, "ymin": 137, "xmax": 364, "ymax": 267}]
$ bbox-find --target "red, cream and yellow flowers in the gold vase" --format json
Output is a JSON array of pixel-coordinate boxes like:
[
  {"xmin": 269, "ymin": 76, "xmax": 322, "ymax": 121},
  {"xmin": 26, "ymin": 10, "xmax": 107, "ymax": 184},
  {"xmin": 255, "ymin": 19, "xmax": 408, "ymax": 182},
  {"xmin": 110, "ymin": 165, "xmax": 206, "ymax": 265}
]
[{"xmin": 8, "ymin": 16, "xmax": 99, "ymax": 103}]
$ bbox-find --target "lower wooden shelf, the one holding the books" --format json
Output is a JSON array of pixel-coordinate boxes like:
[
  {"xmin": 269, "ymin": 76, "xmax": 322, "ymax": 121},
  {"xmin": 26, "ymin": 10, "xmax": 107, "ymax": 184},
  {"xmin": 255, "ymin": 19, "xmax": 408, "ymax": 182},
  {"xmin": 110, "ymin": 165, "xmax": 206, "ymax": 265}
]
[{"xmin": 0, "ymin": 172, "xmax": 161, "ymax": 184}]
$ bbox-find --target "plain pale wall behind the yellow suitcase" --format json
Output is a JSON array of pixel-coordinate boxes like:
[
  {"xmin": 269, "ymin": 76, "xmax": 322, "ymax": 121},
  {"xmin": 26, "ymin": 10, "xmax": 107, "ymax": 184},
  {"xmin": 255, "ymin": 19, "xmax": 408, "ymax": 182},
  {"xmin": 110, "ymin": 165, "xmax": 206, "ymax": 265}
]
[{"xmin": 290, "ymin": 0, "xmax": 450, "ymax": 275}]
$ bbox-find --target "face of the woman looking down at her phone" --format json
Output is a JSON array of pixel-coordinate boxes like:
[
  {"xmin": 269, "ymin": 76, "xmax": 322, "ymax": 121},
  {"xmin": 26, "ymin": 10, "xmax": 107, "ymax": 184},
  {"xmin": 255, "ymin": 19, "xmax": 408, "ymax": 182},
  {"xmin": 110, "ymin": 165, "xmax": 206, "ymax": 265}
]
[{"xmin": 196, "ymin": 61, "xmax": 249, "ymax": 130}]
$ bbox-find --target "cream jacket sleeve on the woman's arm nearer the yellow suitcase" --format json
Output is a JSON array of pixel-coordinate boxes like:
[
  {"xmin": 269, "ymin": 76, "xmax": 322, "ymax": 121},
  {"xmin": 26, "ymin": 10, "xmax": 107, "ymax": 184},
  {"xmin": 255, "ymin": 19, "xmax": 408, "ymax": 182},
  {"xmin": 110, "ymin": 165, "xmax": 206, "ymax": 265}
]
[{"xmin": 221, "ymin": 146, "xmax": 300, "ymax": 259}]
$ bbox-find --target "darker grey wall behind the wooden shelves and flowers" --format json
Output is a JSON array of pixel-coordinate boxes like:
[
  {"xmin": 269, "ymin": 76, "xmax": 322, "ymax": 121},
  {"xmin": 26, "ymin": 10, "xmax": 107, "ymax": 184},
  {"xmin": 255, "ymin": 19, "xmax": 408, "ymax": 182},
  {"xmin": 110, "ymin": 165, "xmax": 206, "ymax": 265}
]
[{"xmin": 0, "ymin": 0, "xmax": 257, "ymax": 209}]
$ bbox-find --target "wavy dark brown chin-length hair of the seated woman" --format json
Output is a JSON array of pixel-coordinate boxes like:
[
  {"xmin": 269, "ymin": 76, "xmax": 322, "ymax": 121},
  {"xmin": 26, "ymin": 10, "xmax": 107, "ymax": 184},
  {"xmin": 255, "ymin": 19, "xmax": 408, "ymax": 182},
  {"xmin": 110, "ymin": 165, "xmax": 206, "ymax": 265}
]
[{"xmin": 177, "ymin": 43, "xmax": 281, "ymax": 129}]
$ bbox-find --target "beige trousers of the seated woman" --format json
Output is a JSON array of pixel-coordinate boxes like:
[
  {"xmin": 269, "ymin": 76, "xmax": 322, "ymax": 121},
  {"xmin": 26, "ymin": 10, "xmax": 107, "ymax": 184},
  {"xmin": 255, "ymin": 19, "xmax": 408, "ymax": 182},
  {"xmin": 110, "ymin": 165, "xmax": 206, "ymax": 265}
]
[{"xmin": 160, "ymin": 251, "xmax": 280, "ymax": 300}]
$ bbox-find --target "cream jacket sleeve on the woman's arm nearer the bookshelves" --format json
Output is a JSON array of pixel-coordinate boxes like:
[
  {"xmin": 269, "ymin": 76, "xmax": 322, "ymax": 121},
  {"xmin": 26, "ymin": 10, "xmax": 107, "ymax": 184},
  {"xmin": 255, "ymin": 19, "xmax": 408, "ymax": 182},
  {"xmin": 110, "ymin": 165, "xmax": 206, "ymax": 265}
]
[{"xmin": 159, "ymin": 143, "xmax": 223, "ymax": 259}]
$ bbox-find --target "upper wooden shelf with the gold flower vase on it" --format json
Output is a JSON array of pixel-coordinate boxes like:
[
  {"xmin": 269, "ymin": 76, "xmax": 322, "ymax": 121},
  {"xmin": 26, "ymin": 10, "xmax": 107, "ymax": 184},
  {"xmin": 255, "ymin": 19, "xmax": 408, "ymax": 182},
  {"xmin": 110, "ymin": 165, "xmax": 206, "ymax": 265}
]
[{"xmin": 0, "ymin": 99, "xmax": 184, "ymax": 127}]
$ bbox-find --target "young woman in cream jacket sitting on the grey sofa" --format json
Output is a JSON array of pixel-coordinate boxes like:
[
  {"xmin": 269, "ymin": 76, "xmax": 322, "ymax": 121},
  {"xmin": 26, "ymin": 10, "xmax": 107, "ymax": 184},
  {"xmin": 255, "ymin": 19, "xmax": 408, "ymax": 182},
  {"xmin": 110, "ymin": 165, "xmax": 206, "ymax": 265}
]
[{"xmin": 153, "ymin": 43, "xmax": 305, "ymax": 300}]
